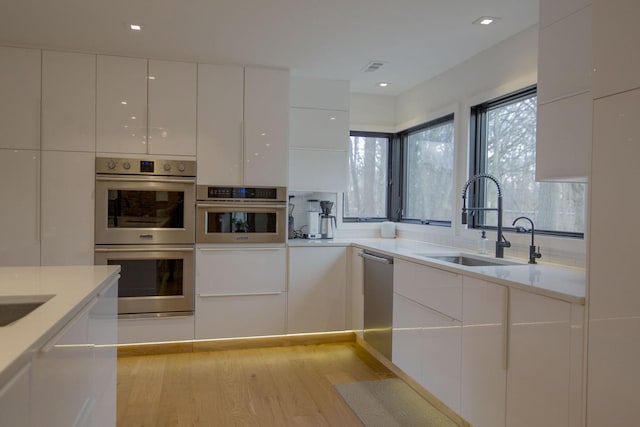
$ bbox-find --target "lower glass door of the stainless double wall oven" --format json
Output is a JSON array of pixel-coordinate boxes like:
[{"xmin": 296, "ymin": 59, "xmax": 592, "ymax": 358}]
[{"xmin": 96, "ymin": 245, "xmax": 194, "ymax": 315}]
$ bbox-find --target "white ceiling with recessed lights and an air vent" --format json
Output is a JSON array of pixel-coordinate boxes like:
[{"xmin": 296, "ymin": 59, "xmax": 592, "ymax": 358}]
[{"xmin": 0, "ymin": 0, "xmax": 539, "ymax": 95}]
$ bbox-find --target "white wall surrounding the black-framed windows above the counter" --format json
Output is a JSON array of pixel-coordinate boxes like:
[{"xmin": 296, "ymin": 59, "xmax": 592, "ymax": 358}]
[{"xmin": 344, "ymin": 26, "xmax": 586, "ymax": 266}]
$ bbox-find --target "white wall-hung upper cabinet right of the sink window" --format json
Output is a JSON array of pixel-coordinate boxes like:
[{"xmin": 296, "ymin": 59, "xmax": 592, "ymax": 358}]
[{"xmin": 536, "ymin": 0, "xmax": 593, "ymax": 182}]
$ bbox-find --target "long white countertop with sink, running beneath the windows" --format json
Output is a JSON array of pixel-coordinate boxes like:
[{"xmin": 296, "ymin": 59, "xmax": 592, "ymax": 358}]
[{"xmin": 288, "ymin": 238, "xmax": 586, "ymax": 305}]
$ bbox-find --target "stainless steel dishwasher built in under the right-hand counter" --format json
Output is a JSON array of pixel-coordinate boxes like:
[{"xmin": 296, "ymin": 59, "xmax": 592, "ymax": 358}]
[{"xmin": 360, "ymin": 251, "xmax": 393, "ymax": 360}]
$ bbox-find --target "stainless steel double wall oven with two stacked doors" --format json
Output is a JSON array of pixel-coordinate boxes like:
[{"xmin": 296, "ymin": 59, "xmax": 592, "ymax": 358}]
[{"xmin": 95, "ymin": 157, "xmax": 196, "ymax": 317}]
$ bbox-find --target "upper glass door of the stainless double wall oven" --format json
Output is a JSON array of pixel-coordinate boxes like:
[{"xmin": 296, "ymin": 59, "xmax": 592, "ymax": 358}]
[{"xmin": 96, "ymin": 177, "xmax": 195, "ymax": 244}]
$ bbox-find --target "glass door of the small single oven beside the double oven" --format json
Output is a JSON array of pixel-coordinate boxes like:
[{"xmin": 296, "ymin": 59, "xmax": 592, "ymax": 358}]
[{"xmin": 196, "ymin": 203, "xmax": 286, "ymax": 243}]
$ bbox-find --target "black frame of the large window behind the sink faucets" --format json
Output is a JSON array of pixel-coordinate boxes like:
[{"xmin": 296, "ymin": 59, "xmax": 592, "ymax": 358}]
[{"xmin": 467, "ymin": 84, "xmax": 584, "ymax": 239}]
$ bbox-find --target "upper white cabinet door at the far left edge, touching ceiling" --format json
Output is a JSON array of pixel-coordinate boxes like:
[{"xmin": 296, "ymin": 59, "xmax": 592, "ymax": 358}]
[{"xmin": 0, "ymin": 47, "xmax": 41, "ymax": 150}]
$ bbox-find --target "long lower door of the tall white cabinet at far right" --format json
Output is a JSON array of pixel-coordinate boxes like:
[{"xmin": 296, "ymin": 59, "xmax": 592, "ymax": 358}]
[{"xmin": 587, "ymin": 85, "xmax": 640, "ymax": 426}]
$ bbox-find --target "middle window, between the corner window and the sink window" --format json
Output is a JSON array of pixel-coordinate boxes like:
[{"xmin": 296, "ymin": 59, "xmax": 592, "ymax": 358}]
[{"xmin": 401, "ymin": 114, "xmax": 455, "ymax": 225}]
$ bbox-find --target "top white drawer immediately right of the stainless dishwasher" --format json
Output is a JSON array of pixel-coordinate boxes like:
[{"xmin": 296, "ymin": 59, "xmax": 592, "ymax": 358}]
[{"xmin": 393, "ymin": 260, "xmax": 462, "ymax": 319}]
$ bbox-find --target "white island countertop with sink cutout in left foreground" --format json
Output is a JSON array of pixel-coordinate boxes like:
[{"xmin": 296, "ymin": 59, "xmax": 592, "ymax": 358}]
[{"xmin": 0, "ymin": 265, "xmax": 120, "ymax": 384}]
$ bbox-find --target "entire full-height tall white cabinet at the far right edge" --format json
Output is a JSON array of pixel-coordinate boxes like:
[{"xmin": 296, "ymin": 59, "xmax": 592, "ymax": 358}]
[{"xmin": 587, "ymin": 0, "xmax": 640, "ymax": 426}]
